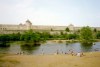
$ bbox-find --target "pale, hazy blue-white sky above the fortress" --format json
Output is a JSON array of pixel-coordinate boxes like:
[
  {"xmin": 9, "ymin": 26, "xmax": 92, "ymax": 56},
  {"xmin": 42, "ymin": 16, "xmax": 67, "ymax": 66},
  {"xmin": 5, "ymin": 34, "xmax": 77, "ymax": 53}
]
[{"xmin": 0, "ymin": 0, "xmax": 100, "ymax": 27}]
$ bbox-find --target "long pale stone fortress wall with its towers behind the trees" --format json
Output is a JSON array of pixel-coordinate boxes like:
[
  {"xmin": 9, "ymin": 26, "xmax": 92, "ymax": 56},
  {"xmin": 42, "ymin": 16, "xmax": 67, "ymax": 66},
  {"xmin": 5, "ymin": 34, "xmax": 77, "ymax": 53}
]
[{"xmin": 0, "ymin": 20, "xmax": 100, "ymax": 34}]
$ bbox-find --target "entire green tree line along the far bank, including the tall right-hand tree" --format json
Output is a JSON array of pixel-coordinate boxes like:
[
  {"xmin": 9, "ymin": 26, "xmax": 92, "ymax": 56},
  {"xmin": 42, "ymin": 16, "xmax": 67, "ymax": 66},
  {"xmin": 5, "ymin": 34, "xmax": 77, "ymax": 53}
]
[{"xmin": 0, "ymin": 26, "xmax": 100, "ymax": 42}]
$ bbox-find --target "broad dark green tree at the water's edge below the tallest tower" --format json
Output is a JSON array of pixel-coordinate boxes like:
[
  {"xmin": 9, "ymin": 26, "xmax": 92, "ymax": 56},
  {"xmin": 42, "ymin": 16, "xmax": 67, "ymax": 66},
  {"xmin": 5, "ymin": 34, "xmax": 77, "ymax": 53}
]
[{"xmin": 20, "ymin": 30, "xmax": 41, "ymax": 46}]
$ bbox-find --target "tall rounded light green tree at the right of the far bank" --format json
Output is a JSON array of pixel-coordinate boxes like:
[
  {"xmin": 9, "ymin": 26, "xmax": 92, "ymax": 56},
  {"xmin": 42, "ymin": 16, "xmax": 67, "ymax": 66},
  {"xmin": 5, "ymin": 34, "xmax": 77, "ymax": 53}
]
[{"xmin": 80, "ymin": 26, "xmax": 93, "ymax": 43}]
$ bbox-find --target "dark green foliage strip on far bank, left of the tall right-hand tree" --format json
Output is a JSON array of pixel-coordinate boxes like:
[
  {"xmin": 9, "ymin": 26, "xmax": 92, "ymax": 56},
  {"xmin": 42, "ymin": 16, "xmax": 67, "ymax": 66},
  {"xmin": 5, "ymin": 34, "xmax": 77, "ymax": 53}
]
[{"xmin": 0, "ymin": 27, "xmax": 90, "ymax": 42}]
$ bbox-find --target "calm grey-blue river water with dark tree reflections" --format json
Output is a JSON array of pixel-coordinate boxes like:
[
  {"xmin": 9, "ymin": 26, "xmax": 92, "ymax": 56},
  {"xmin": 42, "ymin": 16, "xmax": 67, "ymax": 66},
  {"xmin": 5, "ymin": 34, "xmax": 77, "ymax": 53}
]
[{"xmin": 0, "ymin": 41, "xmax": 100, "ymax": 55}]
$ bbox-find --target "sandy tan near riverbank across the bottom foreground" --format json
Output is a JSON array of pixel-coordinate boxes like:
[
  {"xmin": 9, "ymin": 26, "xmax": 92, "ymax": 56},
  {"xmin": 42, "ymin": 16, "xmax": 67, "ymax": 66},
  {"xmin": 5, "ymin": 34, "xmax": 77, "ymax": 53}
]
[{"xmin": 0, "ymin": 52, "xmax": 100, "ymax": 67}]
